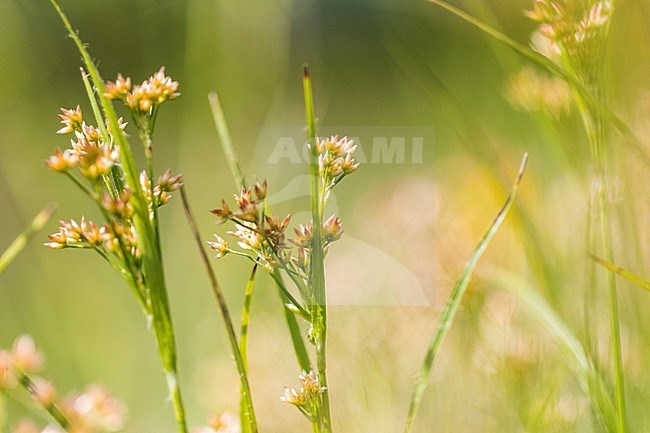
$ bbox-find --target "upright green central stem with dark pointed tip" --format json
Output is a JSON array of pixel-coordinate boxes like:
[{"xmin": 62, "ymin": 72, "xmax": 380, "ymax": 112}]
[{"xmin": 303, "ymin": 65, "xmax": 332, "ymax": 433}]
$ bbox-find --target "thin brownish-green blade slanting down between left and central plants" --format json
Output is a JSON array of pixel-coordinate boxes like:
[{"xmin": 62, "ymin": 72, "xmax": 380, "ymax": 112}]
[{"xmin": 181, "ymin": 187, "xmax": 258, "ymax": 433}]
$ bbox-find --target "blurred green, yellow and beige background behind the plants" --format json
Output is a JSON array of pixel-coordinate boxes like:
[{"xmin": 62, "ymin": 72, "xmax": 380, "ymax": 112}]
[{"xmin": 0, "ymin": 0, "xmax": 650, "ymax": 432}]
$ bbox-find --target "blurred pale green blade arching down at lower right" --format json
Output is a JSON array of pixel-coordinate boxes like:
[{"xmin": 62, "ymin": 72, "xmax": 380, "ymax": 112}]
[{"xmin": 492, "ymin": 271, "xmax": 617, "ymax": 433}]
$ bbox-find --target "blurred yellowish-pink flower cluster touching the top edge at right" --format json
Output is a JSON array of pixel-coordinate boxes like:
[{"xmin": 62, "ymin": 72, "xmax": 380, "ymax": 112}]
[{"xmin": 526, "ymin": 0, "xmax": 614, "ymax": 72}]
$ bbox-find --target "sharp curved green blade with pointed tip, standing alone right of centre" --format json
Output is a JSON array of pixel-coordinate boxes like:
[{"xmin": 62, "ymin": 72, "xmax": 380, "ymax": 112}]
[{"xmin": 404, "ymin": 154, "xmax": 528, "ymax": 433}]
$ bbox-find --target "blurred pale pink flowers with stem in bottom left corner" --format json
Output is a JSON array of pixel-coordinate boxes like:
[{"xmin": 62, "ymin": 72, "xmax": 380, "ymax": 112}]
[{"xmin": 0, "ymin": 336, "xmax": 125, "ymax": 433}]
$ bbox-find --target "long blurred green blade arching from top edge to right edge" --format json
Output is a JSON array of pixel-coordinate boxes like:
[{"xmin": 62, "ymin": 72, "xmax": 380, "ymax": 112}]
[{"xmin": 429, "ymin": 0, "xmax": 650, "ymax": 166}]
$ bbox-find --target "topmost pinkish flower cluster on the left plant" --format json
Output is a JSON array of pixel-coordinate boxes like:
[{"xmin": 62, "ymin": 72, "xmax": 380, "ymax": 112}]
[{"xmin": 104, "ymin": 67, "xmax": 180, "ymax": 113}]
